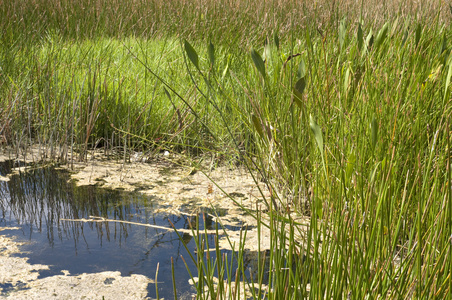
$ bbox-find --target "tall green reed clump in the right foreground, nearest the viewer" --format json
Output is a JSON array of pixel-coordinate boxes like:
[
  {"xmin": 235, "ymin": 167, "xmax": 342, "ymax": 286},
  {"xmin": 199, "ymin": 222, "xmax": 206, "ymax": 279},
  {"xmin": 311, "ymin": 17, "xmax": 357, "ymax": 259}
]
[{"xmin": 168, "ymin": 11, "xmax": 451, "ymax": 299}]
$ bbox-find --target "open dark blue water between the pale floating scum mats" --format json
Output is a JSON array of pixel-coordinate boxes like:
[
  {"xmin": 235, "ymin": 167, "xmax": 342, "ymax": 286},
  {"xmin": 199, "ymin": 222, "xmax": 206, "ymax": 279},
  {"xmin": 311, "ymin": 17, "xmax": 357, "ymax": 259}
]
[{"xmin": 0, "ymin": 161, "xmax": 251, "ymax": 299}]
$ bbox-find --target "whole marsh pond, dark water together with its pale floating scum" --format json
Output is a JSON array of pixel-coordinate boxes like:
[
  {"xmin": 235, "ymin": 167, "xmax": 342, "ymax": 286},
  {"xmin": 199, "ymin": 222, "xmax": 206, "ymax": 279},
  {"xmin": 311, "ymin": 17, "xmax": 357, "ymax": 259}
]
[{"xmin": 0, "ymin": 154, "xmax": 276, "ymax": 299}]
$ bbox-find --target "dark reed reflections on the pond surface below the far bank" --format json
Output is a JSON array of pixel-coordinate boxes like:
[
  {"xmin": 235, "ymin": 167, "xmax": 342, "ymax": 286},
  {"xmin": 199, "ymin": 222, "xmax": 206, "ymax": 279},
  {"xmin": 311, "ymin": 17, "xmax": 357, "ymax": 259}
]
[{"xmin": 0, "ymin": 163, "xmax": 187, "ymax": 250}]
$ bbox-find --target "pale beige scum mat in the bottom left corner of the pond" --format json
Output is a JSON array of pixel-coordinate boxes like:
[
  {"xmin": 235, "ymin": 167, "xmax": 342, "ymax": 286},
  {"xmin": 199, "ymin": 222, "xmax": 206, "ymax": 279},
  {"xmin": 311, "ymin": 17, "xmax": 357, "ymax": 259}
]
[{"xmin": 0, "ymin": 228, "xmax": 153, "ymax": 300}]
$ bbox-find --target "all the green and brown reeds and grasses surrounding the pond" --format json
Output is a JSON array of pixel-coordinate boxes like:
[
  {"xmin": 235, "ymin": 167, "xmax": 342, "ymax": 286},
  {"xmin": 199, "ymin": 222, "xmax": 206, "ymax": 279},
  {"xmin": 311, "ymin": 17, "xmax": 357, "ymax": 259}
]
[{"xmin": 0, "ymin": 0, "xmax": 452, "ymax": 299}]
